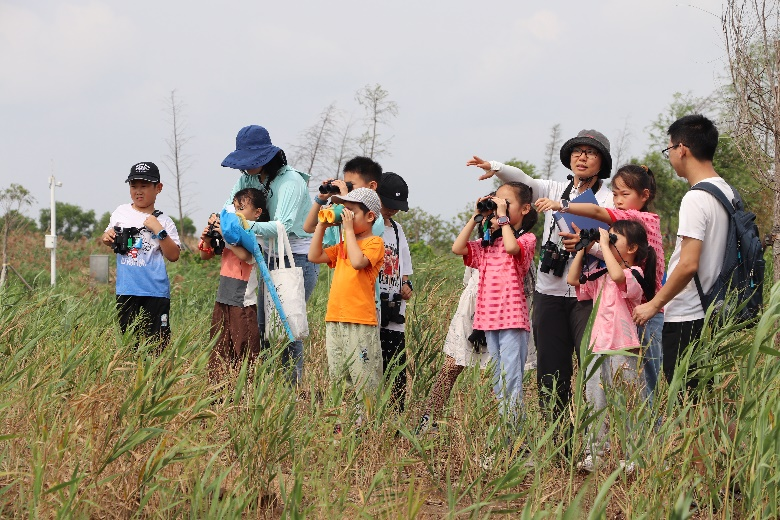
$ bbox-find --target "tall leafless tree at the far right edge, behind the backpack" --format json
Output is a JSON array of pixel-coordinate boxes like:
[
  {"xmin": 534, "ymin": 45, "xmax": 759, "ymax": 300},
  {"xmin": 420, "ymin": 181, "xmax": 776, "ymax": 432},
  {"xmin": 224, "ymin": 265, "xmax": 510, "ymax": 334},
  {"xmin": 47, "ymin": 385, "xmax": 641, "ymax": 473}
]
[{"xmin": 722, "ymin": 0, "xmax": 780, "ymax": 281}]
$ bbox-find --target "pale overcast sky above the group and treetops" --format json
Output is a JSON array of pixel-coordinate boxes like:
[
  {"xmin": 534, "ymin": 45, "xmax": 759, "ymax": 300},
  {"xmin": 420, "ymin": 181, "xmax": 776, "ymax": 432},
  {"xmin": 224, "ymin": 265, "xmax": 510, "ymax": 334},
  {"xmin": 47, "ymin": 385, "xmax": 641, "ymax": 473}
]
[{"xmin": 0, "ymin": 0, "xmax": 725, "ymax": 228}]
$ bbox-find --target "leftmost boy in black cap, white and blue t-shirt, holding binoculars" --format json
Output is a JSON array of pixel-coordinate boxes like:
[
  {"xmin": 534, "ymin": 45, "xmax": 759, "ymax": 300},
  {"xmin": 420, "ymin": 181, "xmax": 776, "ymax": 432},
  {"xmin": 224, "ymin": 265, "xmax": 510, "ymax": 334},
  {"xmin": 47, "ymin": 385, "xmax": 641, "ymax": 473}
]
[{"xmin": 101, "ymin": 162, "xmax": 181, "ymax": 348}]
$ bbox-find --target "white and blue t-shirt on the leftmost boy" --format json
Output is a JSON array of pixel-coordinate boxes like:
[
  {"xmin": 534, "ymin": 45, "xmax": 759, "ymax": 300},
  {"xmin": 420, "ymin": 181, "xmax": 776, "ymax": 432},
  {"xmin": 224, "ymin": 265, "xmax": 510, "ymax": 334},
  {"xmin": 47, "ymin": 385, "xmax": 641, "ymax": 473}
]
[{"xmin": 106, "ymin": 204, "xmax": 181, "ymax": 298}]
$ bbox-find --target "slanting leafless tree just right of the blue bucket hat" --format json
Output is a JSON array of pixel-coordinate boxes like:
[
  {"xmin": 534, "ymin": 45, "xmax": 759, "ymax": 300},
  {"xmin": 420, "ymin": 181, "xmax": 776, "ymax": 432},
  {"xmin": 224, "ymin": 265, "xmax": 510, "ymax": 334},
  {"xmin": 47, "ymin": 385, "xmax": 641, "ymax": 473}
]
[{"xmin": 292, "ymin": 101, "xmax": 341, "ymax": 183}]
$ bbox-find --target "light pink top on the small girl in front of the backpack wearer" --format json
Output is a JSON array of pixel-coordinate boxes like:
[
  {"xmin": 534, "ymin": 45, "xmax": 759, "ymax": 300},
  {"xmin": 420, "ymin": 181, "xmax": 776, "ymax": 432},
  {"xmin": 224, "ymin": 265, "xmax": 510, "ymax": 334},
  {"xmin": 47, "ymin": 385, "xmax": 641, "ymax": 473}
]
[{"xmin": 577, "ymin": 267, "xmax": 642, "ymax": 352}]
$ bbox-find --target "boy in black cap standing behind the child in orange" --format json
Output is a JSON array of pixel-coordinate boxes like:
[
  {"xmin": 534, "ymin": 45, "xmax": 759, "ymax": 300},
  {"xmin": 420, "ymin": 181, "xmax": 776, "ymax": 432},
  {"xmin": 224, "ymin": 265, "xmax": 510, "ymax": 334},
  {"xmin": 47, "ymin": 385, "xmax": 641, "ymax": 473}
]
[{"xmin": 376, "ymin": 172, "xmax": 412, "ymax": 412}]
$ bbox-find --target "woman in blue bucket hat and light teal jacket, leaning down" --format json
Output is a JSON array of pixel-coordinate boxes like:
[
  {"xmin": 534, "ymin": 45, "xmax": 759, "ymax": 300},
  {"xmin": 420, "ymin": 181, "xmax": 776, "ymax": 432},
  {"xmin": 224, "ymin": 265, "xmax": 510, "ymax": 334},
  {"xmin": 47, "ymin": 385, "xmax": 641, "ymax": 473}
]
[{"xmin": 222, "ymin": 125, "xmax": 319, "ymax": 385}]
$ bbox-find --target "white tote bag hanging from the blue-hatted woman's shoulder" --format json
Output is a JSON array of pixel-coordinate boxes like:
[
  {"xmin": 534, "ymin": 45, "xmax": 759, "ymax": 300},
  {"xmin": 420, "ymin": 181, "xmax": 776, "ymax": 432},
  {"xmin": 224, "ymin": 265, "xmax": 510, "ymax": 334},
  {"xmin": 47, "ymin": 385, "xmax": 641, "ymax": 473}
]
[{"xmin": 263, "ymin": 222, "xmax": 309, "ymax": 339}]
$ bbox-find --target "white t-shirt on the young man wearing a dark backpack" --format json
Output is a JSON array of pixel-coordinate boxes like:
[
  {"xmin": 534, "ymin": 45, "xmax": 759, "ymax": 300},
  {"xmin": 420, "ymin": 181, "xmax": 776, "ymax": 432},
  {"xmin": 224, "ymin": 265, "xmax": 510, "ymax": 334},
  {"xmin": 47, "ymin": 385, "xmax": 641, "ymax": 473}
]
[{"xmin": 664, "ymin": 177, "xmax": 734, "ymax": 322}]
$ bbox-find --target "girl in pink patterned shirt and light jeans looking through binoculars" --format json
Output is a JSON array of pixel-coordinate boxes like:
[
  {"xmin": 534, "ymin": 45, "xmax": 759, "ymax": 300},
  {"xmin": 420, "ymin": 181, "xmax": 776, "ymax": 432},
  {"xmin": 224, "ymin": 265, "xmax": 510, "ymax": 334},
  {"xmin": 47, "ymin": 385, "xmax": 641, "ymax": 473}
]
[{"xmin": 452, "ymin": 182, "xmax": 537, "ymax": 431}]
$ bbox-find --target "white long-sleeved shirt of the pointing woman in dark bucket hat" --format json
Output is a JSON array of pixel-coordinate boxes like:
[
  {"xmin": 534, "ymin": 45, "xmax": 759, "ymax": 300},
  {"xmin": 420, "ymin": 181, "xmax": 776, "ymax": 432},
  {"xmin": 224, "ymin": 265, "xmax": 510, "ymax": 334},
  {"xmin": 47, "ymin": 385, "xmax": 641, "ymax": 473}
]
[{"xmin": 491, "ymin": 161, "xmax": 615, "ymax": 298}]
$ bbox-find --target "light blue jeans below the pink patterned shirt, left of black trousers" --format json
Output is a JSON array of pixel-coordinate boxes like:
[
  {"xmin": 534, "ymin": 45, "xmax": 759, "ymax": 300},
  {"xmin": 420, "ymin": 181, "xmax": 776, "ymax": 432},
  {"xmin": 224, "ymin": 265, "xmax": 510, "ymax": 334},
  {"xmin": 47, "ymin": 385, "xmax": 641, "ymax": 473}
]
[{"xmin": 485, "ymin": 329, "xmax": 529, "ymax": 428}]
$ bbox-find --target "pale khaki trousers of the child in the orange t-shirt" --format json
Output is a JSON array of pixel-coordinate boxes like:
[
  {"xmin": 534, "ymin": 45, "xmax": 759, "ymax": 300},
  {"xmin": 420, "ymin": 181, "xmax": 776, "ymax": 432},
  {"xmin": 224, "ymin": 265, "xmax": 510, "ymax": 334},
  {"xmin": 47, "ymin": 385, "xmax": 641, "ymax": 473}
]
[{"xmin": 325, "ymin": 321, "xmax": 382, "ymax": 399}]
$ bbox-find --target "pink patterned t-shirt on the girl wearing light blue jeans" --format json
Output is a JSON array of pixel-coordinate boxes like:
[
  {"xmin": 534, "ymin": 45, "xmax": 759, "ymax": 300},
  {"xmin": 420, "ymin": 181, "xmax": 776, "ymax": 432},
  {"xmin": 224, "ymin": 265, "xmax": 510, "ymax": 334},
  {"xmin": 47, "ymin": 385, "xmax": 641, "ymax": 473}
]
[{"xmin": 463, "ymin": 233, "xmax": 536, "ymax": 331}]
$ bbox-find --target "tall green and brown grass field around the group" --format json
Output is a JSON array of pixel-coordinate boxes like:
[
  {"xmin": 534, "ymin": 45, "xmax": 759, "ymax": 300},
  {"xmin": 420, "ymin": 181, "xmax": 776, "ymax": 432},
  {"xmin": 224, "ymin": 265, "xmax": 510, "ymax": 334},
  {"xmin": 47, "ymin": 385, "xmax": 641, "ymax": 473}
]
[{"xmin": 0, "ymin": 235, "xmax": 780, "ymax": 519}]
